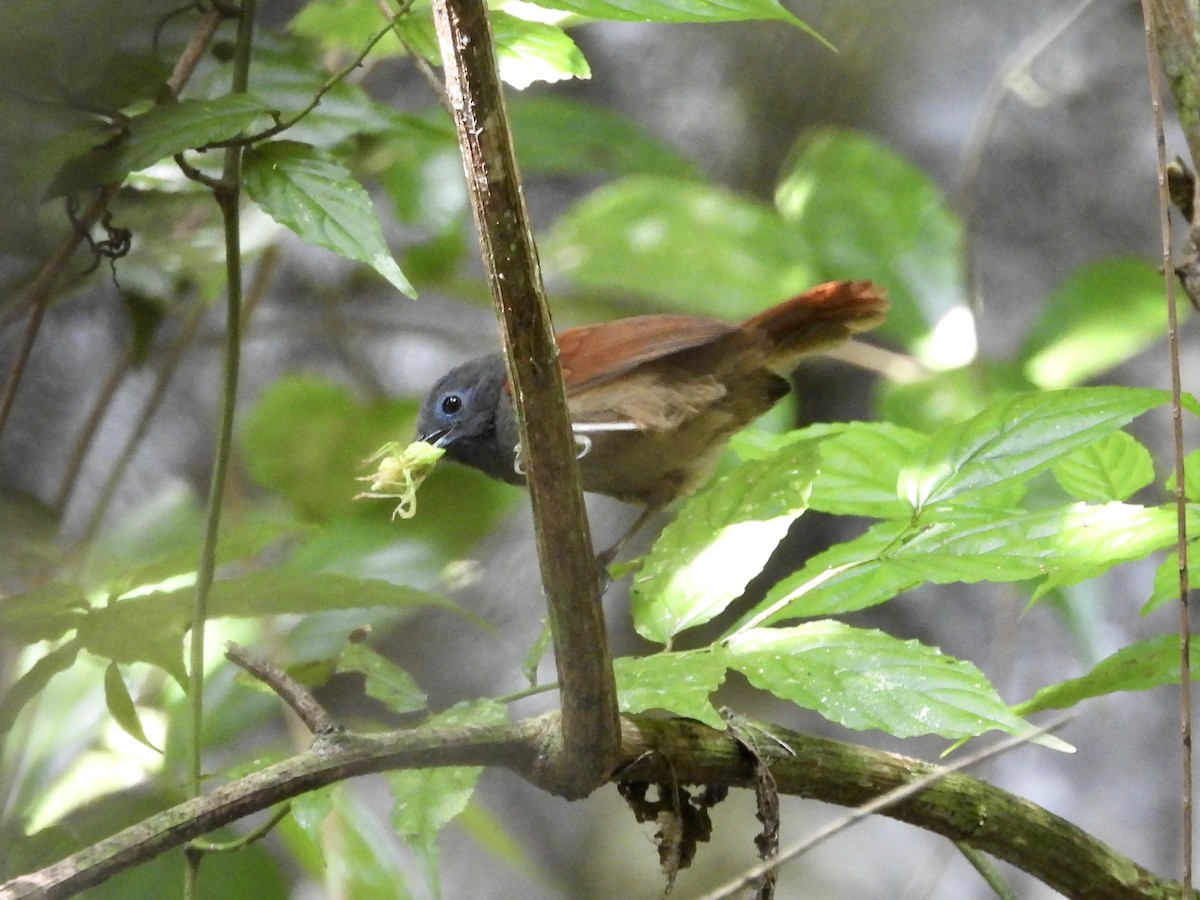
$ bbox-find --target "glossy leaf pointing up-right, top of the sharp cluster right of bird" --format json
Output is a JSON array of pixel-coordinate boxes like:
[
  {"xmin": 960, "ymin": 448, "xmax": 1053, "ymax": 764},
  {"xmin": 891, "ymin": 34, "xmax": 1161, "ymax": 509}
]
[{"xmin": 900, "ymin": 388, "xmax": 1166, "ymax": 511}]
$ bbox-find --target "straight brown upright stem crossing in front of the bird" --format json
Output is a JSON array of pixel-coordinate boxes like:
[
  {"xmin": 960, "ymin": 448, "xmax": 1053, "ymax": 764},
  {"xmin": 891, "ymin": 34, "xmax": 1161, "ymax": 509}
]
[{"xmin": 433, "ymin": 0, "xmax": 618, "ymax": 797}]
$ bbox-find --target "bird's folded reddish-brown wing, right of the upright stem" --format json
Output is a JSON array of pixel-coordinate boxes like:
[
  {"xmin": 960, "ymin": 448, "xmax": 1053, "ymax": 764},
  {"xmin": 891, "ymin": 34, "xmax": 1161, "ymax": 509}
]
[{"xmin": 558, "ymin": 316, "xmax": 738, "ymax": 394}]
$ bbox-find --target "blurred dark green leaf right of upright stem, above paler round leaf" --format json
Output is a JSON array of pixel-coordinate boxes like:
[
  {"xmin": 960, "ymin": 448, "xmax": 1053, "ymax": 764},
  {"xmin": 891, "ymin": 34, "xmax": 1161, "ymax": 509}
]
[{"xmin": 509, "ymin": 95, "xmax": 696, "ymax": 178}]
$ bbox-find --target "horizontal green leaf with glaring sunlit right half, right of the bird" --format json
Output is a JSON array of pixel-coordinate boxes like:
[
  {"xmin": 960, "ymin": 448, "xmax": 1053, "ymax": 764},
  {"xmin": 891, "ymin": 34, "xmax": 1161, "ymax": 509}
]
[{"xmin": 888, "ymin": 503, "xmax": 1185, "ymax": 583}]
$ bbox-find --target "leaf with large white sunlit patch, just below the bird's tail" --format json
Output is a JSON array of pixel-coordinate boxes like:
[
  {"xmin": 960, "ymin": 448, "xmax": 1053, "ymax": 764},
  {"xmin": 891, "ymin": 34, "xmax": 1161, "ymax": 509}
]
[{"xmin": 631, "ymin": 444, "xmax": 820, "ymax": 643}]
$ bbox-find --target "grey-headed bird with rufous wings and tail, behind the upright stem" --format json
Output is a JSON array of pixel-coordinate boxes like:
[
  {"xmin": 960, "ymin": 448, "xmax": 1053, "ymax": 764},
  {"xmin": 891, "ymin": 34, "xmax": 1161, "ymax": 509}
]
[{"xmin": 416, "ymin": 281, "xmax": 888, "ymax": 544}]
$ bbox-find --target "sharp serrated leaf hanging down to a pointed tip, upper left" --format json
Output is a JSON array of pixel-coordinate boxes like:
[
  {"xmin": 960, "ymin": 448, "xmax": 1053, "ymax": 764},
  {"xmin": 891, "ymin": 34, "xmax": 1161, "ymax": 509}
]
[{"xmin": 242, "ymin": 140, "xmax": 416, "ymax": 296}]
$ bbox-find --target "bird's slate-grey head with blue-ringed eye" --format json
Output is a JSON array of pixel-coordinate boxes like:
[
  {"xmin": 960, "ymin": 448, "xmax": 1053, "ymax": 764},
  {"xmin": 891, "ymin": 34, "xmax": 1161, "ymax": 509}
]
[{"xmin": 416, "ymin": 353, "xmax": 523, "ymax": 484}]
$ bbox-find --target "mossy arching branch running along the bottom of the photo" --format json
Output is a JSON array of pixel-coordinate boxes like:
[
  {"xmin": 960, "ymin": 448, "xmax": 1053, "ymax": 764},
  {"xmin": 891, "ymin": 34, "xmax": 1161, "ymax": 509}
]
[{"xmin": 0, "ymin": 713, "xmax": 1182, "ymax": 900}]
